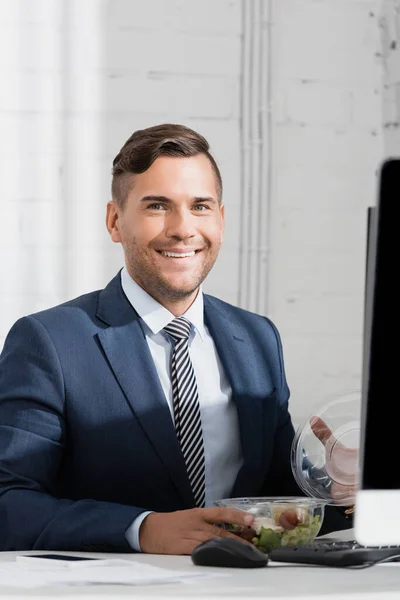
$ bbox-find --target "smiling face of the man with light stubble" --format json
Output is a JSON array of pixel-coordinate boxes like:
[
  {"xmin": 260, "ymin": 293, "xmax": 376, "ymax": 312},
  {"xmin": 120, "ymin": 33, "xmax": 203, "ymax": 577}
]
[{"xmin": 107, "ymin": 154, "xmax": 224, "ymax": 302}]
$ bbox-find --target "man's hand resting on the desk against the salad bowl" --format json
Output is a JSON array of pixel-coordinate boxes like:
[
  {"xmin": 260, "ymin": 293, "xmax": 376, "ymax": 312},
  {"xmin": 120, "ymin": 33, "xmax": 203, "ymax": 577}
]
[{"xmin": 139, "ymin": 507, "xmax": 254, "ymax": 554}]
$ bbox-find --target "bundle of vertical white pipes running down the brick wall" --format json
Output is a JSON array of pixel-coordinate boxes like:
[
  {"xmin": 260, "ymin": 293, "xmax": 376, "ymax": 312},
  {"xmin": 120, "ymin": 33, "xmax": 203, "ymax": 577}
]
[{"xmin": 239, "ymin": 0, "xmax": 272, "ymax": 314}]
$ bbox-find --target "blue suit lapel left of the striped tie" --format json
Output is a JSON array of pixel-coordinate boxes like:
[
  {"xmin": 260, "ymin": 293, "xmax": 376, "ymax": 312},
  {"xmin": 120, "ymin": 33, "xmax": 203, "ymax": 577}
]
[{"xmin": 97, "ymin": 275, "xmax": 194, "ymax": 507}]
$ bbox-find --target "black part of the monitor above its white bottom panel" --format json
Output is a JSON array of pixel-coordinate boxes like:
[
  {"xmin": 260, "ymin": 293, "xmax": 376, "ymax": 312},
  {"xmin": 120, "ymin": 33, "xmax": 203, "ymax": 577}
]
[{"xmin": 361, "ymin": 159, "xmax": 400, "ymax": 490}]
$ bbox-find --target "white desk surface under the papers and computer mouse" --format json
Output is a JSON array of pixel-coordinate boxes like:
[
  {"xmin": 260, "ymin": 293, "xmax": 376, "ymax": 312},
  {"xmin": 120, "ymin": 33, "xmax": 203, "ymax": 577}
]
[{"xmin": 0, "ymin": 552, "xmax": 400, "ymax": 600}]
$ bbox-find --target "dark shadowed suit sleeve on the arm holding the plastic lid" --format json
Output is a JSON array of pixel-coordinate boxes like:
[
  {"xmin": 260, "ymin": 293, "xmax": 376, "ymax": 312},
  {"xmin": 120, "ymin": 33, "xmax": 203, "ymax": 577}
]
[{"xmin": 261, "ymin": 323, "xmax": 352, "ymax": 535}]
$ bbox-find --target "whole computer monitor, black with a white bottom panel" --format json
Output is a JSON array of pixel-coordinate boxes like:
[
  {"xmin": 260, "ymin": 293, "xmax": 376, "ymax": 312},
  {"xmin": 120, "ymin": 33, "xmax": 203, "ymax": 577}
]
[{"xmin": 355, "ymin": 158, "xmax": 400, "ymax": 546}]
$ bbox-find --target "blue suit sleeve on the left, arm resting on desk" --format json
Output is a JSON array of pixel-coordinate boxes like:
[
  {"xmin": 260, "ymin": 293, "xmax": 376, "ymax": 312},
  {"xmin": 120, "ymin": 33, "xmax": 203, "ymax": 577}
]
[{"xmin": 0, "ymin": 317, "xmax": 144, "ymax": 552}]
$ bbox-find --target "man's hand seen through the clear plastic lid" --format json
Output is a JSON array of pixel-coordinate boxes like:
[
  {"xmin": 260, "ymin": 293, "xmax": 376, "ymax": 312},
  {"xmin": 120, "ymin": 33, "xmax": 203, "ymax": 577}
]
[{"xmin": 310, "ymin": 417, "xmax": 359, "ymax": 503}]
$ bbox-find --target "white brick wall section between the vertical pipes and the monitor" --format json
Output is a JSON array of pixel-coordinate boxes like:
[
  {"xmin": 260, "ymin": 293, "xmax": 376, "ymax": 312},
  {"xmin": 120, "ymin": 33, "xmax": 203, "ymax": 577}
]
[{"xmin": 269, "ymin": 0, "xmax": 382, "ymax": 422}]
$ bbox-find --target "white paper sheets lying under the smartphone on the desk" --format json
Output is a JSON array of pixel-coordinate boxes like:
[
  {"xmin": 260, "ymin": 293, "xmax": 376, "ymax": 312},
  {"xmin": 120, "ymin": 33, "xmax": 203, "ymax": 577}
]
[{"xmin": 0, "ymin": 561, "xmax": 225, "ymax": 588}]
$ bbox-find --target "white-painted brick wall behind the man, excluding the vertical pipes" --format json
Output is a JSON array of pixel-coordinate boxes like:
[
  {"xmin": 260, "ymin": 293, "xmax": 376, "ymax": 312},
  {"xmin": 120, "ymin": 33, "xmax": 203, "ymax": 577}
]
[{"xmin": 0, "ymin": 0, "xmax": 400, "ymax": 421}]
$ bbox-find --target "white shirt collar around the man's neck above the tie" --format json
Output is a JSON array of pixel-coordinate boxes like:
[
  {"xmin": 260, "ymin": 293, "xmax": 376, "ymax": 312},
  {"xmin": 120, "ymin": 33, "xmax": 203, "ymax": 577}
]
[{"xmin": 121, "ymin": 267, "xmax": 205, "ymax": 339}]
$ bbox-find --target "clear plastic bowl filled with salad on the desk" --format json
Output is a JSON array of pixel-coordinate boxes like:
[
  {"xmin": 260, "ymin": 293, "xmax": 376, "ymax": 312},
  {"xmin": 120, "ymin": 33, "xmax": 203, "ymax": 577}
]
[{"xmin": 214, "ymin": 497, "xmax": 326, "ymax": 552}]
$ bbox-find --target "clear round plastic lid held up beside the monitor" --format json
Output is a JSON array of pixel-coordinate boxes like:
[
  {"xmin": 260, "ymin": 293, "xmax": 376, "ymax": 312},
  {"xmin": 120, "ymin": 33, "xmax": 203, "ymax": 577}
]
[{"xmin": 291, "ymin": 392, "xmax": 361, "ymax": 506}]
